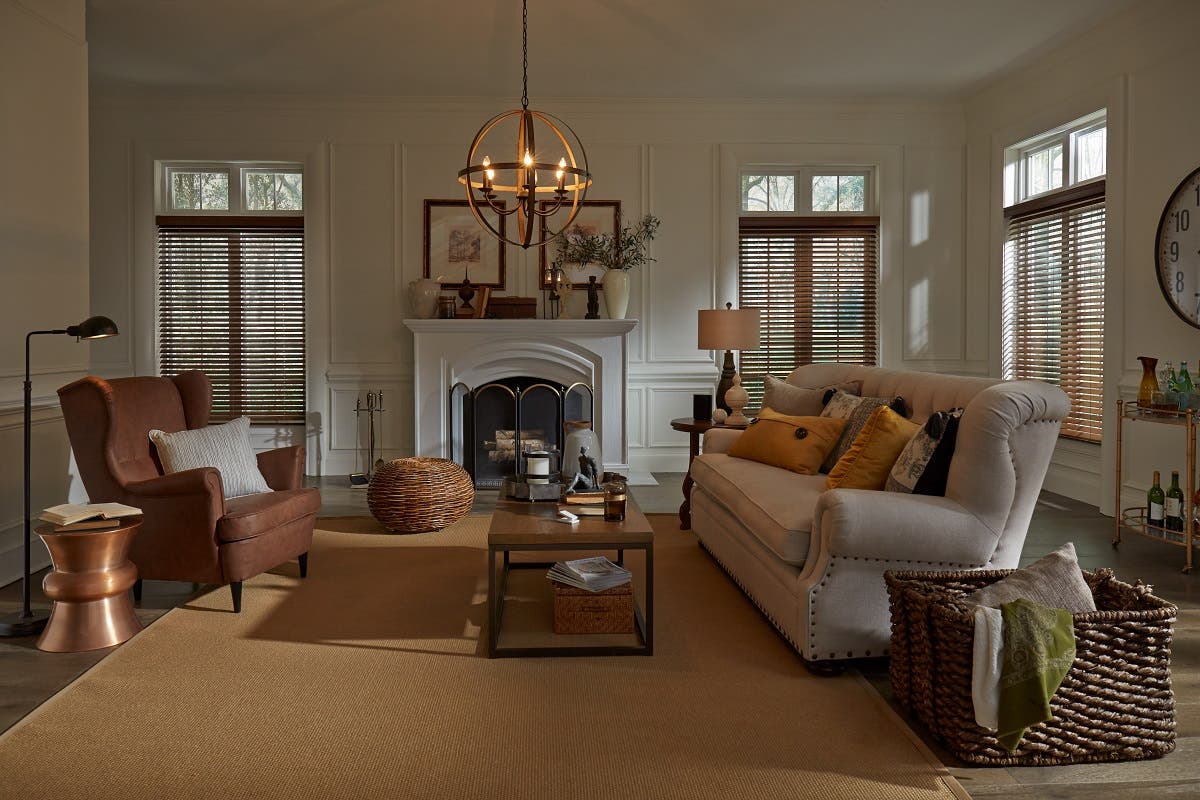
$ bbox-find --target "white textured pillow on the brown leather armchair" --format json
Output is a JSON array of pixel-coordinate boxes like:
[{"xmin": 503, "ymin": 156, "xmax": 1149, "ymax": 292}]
[{"xmin": 150, "ymin": 416, "xmax": 271, "ymax": 498}]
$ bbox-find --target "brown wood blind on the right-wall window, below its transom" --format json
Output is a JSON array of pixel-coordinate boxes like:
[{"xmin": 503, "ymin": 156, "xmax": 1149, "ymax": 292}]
[{"xmin": 1003, "ymin": 182, "xmax": 1105, "ymax": 441}]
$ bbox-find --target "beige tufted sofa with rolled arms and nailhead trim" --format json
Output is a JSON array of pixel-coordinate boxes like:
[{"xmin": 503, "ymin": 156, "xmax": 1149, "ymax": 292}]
[{"xmin": 691, "ymin": 363, "xmax": 1070, "ymax": 662}]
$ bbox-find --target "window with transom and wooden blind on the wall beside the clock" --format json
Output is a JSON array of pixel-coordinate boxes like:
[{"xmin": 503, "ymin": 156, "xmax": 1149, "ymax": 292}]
[{"xmin": 1002, "ymin": 115, "xmax": 1106, "ymax": 441}]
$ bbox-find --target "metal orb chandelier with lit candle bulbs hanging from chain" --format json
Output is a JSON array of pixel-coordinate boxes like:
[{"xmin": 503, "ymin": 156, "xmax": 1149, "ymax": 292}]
[{"xmin": 458, "ymin": 0, "xmax": 592, "ymax": 248}]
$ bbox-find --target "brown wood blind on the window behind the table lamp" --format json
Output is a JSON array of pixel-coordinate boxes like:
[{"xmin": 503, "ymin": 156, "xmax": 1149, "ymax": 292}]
[{"xmin": 738, "ymin": 217, "xmax": 880, "ymax": 408}]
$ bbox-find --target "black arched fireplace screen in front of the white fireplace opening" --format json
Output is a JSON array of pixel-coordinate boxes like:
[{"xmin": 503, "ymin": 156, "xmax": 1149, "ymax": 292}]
[{"xmin": 450, "ymin": 377, "xmax": 595, "ymax": 488}]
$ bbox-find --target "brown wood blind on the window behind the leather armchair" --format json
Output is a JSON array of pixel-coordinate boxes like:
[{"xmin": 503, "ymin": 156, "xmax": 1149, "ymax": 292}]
[{"xmin": 157, "ymin": 217, "xmax": 305, "ymax": 423}]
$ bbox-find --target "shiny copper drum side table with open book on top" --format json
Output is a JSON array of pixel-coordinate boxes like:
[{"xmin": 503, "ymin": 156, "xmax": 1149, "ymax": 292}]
[{"xmin": 37, "ymin": 517, "xmax": 142, "ymax": 652}]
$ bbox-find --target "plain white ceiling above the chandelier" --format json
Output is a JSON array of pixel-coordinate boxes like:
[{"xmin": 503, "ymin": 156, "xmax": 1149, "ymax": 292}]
[{"xmin": 88, "ymin": 0, "xmax": 1133, "ymax": 100}]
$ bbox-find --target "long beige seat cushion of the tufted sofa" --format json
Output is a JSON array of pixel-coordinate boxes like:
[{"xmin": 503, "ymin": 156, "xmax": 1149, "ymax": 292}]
[{"xmin": 691, "ymin": 453, "xmax": 826, "ymax": 566}]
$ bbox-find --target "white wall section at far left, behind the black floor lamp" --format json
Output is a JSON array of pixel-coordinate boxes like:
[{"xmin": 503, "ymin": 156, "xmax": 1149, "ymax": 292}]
[{"xmin": 0, "ymin": 0, "xmax": 89, "ymax": 585}]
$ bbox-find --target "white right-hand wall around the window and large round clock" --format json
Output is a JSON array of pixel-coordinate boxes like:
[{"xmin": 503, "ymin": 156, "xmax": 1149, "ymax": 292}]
[{"xmin": 966, "ymin": 0, "xmax": 1200, "ymax": 513}]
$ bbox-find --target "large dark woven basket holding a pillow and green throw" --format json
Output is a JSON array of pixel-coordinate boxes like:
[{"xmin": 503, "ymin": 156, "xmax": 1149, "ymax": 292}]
[{"xmin": 883, "ymin": 570, "xmax": 1177, "ymax": 766}]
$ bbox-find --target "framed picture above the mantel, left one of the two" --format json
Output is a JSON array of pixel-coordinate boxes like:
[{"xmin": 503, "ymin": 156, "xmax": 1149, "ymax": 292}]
[{"xmin": 422, "ymin": 200, "xmax": 505, "ymax": 289}]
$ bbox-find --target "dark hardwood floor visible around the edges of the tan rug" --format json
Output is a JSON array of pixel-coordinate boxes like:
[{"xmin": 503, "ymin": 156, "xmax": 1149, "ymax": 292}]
[{"xmin": 0, "ymin": 473, "xmax": 1200, "ymax": 800}]
